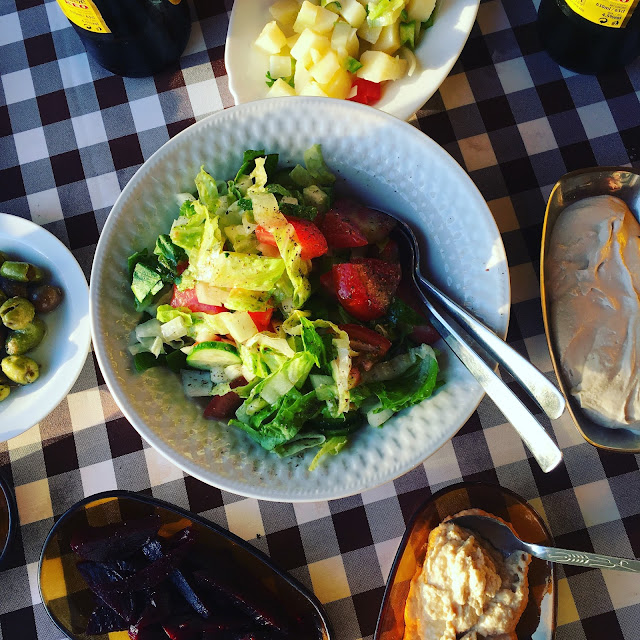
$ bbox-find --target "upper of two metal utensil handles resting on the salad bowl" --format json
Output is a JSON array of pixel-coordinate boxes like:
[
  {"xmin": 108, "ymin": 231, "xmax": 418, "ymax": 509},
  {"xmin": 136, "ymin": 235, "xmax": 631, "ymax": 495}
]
[{"xmin": 417, "ymin": 274, "xmax": 565, "ymax": 419}]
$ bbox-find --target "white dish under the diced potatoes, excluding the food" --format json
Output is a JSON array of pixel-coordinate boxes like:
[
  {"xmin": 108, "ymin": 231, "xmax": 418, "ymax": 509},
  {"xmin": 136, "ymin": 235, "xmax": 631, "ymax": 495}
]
[{"xmin": 224, "ymin": 0, "xmax": 480, "ymax": 120}]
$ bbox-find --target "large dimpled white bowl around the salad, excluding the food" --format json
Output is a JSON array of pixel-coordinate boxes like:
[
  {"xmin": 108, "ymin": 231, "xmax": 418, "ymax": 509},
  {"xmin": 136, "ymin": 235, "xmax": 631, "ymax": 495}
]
[{"xmin": 91, "ymin": 97, "xmax": 509, "ymax": 501}]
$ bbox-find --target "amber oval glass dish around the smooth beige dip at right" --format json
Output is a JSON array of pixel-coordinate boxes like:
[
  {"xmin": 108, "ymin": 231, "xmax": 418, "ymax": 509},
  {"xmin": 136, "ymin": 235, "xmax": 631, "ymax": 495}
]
[{"xmin": 540, "ymin": 167, "xmax": 640, "ymax": 453}]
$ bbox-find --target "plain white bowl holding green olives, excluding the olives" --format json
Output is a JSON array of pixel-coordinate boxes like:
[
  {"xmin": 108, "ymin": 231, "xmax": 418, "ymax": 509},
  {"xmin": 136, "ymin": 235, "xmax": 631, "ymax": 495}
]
[{"xmin": 0, "ymin": 213, "xmax": 91, "ymax": 441}]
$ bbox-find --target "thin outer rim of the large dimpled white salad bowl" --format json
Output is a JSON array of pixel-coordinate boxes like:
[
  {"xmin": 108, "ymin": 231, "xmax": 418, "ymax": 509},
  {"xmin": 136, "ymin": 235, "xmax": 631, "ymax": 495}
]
[{"xmin": 89, "ymin": 96, "xmax": 511, "ymax": 503}]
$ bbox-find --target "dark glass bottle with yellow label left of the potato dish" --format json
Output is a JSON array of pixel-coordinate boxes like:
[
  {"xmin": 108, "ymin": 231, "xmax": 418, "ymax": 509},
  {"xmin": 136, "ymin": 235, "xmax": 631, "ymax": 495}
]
[{"xmin": 58, "ymin": 0, "xmax": 191, "ymax": 77}]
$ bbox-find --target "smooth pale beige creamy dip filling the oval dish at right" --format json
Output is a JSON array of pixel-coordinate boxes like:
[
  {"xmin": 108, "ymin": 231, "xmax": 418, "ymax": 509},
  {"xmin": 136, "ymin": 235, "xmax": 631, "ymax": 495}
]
[{"xmin": 546, "ymin": 196, "xmax": 640, "ymax": 429}]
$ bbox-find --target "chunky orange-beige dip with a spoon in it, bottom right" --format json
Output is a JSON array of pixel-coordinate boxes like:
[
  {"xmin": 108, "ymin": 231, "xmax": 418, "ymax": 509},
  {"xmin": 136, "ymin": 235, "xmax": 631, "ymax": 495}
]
[{"xmin": 404, "ymin": 509, "xmax": 531, "ymax": 640}]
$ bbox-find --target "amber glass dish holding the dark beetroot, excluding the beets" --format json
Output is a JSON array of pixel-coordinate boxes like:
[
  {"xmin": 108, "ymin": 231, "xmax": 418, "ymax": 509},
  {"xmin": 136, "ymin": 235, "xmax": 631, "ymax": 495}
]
[{"xmin": 38, "ymin": 491, "xmax": 332, "ymax": 640}]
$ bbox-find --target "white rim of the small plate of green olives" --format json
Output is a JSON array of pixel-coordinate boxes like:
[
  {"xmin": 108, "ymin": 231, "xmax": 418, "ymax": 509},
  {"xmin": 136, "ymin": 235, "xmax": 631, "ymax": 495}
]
[{"xmin": 0, "ymin": 213, "xmax": 91, "ymax": 441}]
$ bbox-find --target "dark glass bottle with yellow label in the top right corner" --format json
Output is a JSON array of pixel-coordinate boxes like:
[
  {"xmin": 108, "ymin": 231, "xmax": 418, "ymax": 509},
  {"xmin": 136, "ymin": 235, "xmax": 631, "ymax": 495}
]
[{"xmin": 538, "ymin": 0, "xmax": 640, "ymax": 73}]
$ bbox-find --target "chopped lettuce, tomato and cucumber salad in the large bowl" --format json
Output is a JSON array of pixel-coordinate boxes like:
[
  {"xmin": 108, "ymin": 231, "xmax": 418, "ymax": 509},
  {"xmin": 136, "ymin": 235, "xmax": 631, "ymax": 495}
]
[{"xmin": 128, "ymin": 145, "xmax": 438, "ymax": 469}]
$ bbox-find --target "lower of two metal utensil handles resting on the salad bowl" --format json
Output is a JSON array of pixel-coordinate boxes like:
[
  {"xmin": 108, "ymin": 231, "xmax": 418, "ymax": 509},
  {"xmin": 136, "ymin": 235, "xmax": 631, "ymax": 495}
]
[{"xmin": 417, "ymin": 292, "xmax": 562, "ymax": 473}]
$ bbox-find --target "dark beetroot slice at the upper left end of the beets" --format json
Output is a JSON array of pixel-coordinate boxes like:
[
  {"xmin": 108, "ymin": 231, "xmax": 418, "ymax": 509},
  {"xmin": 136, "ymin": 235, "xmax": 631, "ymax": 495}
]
[{"xmin": 70, "ymin": 514, "xmax": 162, "ymax": 562}]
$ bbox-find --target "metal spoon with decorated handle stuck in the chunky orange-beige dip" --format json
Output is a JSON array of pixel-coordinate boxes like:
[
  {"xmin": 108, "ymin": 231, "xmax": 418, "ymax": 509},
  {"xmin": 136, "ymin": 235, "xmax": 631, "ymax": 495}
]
[{"xmin": 448, "ymin": 516, "xmax": 640, "ymax": 573}]
